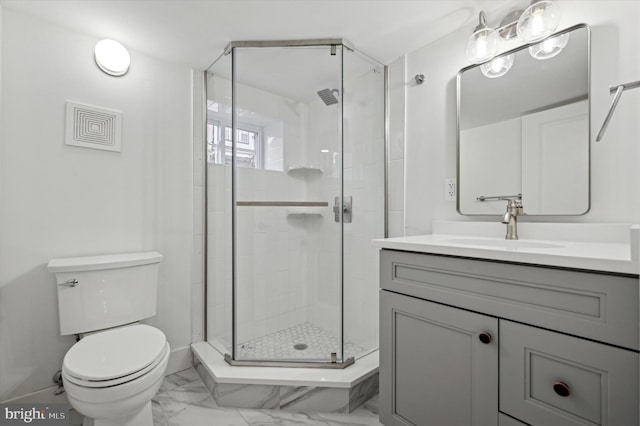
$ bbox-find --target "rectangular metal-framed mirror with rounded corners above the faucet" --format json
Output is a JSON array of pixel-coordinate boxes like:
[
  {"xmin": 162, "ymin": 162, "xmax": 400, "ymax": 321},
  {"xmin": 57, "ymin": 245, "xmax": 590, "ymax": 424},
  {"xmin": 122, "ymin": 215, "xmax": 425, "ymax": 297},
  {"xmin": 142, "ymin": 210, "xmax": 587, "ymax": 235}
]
[{"xmin": 457, "ymin": 25, "xmax": 590, "ymax": 215}]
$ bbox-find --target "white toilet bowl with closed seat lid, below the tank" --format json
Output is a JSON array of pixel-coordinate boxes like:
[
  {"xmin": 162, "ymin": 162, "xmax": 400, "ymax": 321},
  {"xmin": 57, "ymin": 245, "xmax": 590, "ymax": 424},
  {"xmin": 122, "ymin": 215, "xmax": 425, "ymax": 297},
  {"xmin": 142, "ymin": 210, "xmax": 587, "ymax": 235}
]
[{"xmin": 62, "ymin": 324, "xmax": 170, "ymax": 426}]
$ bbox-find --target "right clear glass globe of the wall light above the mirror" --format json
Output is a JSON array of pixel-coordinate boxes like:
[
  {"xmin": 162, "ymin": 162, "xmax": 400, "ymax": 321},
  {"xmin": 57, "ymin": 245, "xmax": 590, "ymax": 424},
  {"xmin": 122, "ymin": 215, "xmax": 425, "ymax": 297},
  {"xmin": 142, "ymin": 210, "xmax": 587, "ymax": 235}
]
[{"xmin": 516, "ymin": 0, "xmax": 560, "ymax": 43}]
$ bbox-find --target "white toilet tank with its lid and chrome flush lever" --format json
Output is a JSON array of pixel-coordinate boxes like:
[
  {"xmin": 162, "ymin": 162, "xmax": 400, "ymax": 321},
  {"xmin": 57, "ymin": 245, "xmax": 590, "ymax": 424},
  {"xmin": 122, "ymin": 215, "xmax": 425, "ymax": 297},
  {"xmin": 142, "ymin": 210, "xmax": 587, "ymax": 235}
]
[{"xmin": 48, "ymin": 251, "xmax": 162, "ymax": 335}]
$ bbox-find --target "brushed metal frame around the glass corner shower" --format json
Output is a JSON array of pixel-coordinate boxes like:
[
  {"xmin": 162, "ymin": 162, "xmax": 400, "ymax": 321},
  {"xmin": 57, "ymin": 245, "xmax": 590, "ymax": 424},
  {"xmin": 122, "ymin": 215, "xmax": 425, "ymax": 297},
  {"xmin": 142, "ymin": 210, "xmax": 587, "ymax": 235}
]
[{"xmin": 203, "ymin": 38, "xmax": 390, "ymax": 369}]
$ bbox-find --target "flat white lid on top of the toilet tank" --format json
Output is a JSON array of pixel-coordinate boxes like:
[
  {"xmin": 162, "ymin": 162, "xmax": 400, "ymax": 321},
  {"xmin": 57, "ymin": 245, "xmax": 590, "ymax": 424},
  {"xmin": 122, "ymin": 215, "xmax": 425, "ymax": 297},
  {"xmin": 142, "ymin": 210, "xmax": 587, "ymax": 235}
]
[{"xmin": 47, "ymin": 251, "xmax": 162, "ymax": 272}]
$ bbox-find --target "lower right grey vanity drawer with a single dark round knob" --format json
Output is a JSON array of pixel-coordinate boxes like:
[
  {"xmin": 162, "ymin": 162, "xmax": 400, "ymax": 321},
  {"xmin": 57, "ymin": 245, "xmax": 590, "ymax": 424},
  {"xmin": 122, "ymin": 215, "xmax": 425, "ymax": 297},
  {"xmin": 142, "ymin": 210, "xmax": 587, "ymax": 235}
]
[{"xmin": 500, "ymin": 320, "xmax": 638, "ymax": 426}]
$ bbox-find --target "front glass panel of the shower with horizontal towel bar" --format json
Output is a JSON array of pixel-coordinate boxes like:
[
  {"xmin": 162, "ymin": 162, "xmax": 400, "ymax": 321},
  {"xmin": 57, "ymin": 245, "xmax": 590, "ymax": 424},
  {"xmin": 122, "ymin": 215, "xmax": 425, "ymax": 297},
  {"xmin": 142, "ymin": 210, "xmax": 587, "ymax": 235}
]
[{"xmin": 230, "ymin": 45, "xmax": 344, "ymax": 363}]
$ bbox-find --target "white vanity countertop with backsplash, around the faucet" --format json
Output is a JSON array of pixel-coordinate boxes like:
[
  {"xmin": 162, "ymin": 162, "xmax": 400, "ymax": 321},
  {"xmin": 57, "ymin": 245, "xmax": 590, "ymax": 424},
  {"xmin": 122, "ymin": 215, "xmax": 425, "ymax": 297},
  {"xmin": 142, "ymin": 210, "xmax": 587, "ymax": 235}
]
[{"xmin": 373, "ymin": 222, "xmax": 640, "ymax": 275}]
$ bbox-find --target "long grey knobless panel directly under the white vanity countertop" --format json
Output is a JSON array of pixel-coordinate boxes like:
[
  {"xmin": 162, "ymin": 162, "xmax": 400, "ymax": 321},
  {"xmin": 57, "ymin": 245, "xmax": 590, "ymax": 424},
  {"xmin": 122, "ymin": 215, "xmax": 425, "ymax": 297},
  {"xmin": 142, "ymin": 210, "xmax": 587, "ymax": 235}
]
[{"xmin": 380, "ymin": 250, "xmax": 639, "ymax": 350}]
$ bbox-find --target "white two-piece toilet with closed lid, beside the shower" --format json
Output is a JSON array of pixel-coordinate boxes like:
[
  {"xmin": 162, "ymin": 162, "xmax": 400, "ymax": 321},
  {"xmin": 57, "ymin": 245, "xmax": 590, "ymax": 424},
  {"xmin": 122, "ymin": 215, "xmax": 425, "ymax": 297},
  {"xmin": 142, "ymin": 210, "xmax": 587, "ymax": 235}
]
[{"xmin": 48, "ymin": 252, "xmax": 170, "ymax": 426}]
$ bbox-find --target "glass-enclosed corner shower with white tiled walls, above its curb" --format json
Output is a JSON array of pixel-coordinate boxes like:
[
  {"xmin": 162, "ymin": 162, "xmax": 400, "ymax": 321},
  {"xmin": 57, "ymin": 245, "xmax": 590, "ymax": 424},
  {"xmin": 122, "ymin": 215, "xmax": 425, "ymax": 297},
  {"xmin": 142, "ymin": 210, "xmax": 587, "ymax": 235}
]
[{"xmin": 205, "ymin": 39, "xmax": 386, "ymax": 368}]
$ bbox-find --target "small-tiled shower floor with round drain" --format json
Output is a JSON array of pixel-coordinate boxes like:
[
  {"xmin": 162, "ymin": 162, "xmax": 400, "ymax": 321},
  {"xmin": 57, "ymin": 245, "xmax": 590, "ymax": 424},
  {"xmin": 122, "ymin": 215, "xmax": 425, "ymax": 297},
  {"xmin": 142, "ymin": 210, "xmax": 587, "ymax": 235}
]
[{"xmin": 229, "ymin": 322, "xmax": 364, "ymax": 361}]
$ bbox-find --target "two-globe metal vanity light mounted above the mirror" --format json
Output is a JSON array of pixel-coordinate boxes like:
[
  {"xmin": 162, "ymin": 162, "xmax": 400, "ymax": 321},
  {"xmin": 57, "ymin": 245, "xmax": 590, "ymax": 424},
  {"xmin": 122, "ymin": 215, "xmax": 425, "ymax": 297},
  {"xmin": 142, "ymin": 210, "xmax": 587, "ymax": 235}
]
[{"xmin": 466, "ymin": 0, "xmax": 562, "ymax": 65}]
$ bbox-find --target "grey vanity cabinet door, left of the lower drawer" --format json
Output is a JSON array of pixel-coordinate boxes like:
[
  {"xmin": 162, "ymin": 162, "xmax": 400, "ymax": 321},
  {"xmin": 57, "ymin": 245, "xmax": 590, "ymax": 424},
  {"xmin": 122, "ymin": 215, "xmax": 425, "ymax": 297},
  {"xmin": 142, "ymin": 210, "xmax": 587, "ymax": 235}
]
[{"xmin": 380, "ymin": 291, "xmax": 498, "ymax": 426}]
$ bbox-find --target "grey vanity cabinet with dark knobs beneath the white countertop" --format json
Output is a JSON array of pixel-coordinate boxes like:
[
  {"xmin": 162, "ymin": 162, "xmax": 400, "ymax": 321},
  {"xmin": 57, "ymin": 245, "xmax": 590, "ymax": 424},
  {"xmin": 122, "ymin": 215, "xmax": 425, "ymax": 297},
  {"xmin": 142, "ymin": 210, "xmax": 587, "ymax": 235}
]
[{"xmin": 380, "ymin": 250, "xmax": 639, "ymax": 426}]
